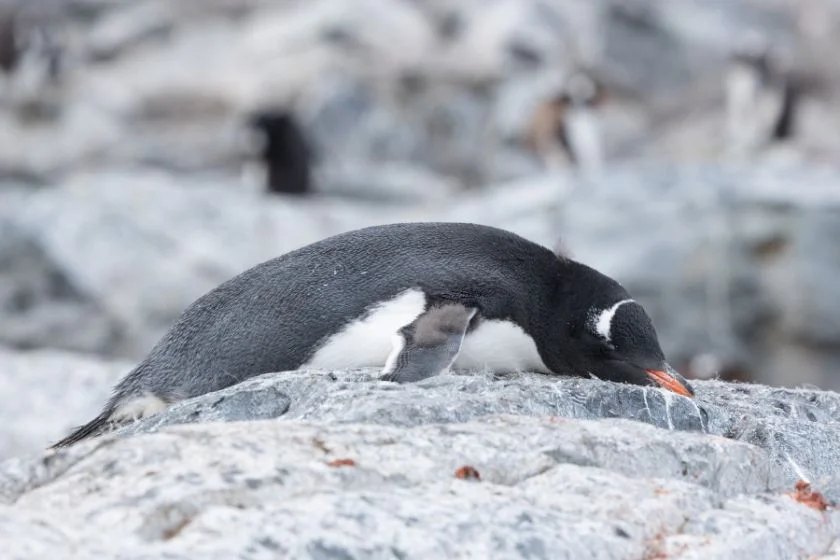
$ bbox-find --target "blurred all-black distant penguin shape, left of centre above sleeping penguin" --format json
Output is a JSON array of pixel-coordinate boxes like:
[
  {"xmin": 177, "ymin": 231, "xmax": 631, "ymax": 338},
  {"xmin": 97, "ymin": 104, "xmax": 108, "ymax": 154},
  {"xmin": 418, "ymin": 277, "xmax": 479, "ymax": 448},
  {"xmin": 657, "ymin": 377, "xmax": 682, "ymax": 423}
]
[{"xmin": 248, "ymin": 111, "xmax": 313, "ymax": 195}]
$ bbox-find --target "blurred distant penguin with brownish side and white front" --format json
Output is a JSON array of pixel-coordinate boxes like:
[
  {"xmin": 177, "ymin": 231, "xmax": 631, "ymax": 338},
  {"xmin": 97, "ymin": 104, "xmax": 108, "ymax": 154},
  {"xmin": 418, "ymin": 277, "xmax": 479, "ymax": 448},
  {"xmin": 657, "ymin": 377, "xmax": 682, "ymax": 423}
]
[{"xmin": 528, "ymin": 72, "xmax": 604, "ymax": 170}]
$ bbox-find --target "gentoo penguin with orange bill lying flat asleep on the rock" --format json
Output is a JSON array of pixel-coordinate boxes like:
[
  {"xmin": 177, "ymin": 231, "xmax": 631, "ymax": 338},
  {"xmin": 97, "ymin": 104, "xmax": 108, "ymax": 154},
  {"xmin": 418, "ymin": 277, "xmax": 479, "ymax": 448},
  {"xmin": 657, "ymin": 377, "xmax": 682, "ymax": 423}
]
[{"xmin": 53, "ymin": 223, "xmax": 693, "ymax": 447}]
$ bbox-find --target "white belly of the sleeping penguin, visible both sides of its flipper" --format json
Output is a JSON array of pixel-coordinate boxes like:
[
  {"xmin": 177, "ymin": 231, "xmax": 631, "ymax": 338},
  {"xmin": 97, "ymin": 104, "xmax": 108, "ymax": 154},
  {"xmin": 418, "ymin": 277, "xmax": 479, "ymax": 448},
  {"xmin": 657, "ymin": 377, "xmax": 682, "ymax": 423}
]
[{"xmin": 301, "ymin": 290, "xmax": 549, "ymax": 373}]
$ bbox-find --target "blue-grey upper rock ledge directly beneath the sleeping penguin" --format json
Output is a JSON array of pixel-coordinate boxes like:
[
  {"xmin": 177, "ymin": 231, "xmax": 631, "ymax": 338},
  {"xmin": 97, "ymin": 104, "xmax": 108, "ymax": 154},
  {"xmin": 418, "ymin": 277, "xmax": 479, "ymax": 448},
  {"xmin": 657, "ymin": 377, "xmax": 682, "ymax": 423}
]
[{"xmin": 110, "ymin": 372, "xmax": 840, "ymax": 498}]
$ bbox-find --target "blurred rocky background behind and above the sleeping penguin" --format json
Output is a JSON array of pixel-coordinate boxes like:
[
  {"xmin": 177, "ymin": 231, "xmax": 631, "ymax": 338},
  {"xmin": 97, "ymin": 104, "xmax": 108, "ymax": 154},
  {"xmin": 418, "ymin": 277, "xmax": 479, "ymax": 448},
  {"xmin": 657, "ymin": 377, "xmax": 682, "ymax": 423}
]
[{"xmin": 0, "ymin": 0, "xmax": 840, "ymax": 422}]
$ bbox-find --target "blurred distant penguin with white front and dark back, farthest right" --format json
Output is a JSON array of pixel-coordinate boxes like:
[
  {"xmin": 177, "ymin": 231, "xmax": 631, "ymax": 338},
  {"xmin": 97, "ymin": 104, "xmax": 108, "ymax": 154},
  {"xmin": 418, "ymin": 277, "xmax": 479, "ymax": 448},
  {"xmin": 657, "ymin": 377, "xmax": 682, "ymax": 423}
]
[{"xmin": 725, "ymin": 37, "xmax": 799, "ymax": 154}]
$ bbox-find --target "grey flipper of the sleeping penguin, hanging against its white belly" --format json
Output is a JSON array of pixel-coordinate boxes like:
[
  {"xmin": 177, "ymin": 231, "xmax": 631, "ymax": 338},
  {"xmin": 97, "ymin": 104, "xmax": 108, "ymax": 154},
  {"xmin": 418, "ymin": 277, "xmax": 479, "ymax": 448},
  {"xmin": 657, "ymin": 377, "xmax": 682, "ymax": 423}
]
[{"xmin": 380, "ymin": 303, "xmax": 477, "ymax": 383}]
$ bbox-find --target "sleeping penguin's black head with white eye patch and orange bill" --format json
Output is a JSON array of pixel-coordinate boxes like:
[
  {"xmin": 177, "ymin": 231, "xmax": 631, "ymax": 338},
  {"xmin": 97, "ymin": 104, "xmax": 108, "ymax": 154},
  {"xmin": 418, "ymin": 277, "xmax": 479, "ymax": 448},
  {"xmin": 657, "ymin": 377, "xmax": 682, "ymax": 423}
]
[{"xmin": 570, "ymin": 299, "xmax": 694, "ymax": 397}]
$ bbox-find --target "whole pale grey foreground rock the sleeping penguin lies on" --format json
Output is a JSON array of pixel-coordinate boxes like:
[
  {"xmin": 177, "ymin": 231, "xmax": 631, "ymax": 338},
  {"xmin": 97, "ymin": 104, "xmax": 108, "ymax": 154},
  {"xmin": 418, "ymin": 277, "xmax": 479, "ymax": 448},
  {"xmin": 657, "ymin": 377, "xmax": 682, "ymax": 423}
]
[{"xmin": 0, "ymin": 371, "xmax": 840, "ymax": 560}]
